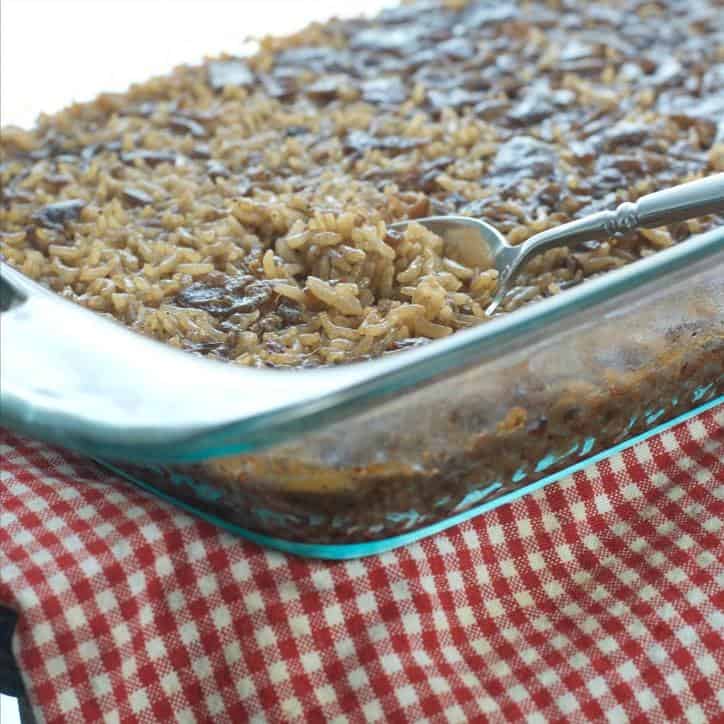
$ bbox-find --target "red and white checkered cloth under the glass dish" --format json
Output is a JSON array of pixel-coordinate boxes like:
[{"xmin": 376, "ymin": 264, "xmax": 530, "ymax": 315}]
[{"xmin": 0, "ymin": 406, "xmax": 724, "ymax": 724}]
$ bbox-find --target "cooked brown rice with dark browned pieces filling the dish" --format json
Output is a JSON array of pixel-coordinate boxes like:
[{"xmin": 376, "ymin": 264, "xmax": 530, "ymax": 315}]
[{"xmin": 0, "ymin": 0, "xmax": 724, "ymax": 366}]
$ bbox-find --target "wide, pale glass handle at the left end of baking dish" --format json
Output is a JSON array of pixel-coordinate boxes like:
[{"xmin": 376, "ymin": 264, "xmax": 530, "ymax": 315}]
[{"xmin": 0, "ymin": 261, "xmax": 284, "ymax": 449}]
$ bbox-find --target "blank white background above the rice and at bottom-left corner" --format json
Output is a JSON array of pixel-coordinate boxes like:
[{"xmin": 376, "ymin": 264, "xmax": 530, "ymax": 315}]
[{"xmin": 0, "ymin": 0, "xmax": 396, "ymax": 724}]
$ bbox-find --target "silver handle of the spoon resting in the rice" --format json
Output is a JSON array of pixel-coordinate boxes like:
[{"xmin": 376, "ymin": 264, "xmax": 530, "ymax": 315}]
[{"xmin": 516, "ymin": 173, "xmax": 724, "ymax": 282}]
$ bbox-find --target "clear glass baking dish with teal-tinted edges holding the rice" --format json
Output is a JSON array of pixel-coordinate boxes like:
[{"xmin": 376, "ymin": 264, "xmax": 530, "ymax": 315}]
[{"xmin": 0, "ymin": 227, "xmax": 724, "ymax": 558}]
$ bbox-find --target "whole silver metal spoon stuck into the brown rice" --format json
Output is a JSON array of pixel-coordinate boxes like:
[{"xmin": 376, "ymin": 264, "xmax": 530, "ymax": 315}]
[{"xmin": 391, "ymin": 173, "xmax": 724, "ymax": 316}]
